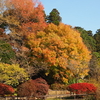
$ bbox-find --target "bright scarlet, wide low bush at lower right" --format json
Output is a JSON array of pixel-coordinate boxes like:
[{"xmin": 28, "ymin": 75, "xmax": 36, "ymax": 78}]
[{"xmin": 67, "ymin": 83, "xmax": 96, "ymax": 94}]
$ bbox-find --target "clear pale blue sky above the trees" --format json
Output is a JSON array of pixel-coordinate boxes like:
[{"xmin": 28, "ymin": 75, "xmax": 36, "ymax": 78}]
[{"xmin": 40, "ymin": 0, "xmax": 100, "ymax": 34}]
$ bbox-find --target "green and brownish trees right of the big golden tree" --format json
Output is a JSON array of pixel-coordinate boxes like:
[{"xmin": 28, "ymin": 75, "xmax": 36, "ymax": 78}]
[{"xmin": 75, "ymin": 27, "xmax": 100, "ymax": 81}]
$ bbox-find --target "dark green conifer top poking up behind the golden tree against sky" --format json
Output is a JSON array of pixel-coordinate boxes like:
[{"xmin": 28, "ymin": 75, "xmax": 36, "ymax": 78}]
[{"xmin": 46, "ymin": 9, "xmax": 61, "ymax": 25}]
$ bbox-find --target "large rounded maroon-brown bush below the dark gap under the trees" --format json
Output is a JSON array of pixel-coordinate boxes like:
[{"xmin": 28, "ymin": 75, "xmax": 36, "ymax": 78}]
[{"xmin": 17, "ymin": 78, "xmax": 49, "ymax": 97}]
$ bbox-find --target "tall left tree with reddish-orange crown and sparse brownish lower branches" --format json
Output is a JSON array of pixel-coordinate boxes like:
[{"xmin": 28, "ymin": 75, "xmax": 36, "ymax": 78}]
[{"xmin": 0, "ymin": 0, "xmax": 47, "ymax": 75}]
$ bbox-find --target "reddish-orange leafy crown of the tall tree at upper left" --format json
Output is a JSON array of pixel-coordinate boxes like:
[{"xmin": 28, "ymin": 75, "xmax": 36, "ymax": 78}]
[{"xmin": 6, "ymin": 0, "xmax": 47, "ymax": 34}]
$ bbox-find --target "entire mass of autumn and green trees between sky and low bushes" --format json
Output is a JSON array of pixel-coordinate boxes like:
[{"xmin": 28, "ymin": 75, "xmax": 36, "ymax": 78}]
[{"xmin": 0, "ymin": 0, "xmax": 100, "ymax": 88}]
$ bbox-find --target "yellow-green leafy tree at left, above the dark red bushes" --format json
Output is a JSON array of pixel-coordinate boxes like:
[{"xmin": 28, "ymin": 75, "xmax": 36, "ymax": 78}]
[{"xmin": 0, "ymin": 63, "xmax": 29, "ymax": 87}]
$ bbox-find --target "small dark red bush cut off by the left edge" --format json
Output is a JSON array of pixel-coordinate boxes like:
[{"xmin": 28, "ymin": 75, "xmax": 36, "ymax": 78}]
[{"xmin": 0, "ymin": 83, "xmax": 15, "ymax": 96}]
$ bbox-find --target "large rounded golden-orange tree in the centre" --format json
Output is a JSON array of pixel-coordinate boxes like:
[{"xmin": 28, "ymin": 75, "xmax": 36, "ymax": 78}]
[{"xmin": 27, "ymin": 23, "xmax": 91, "ymax": 83}]
